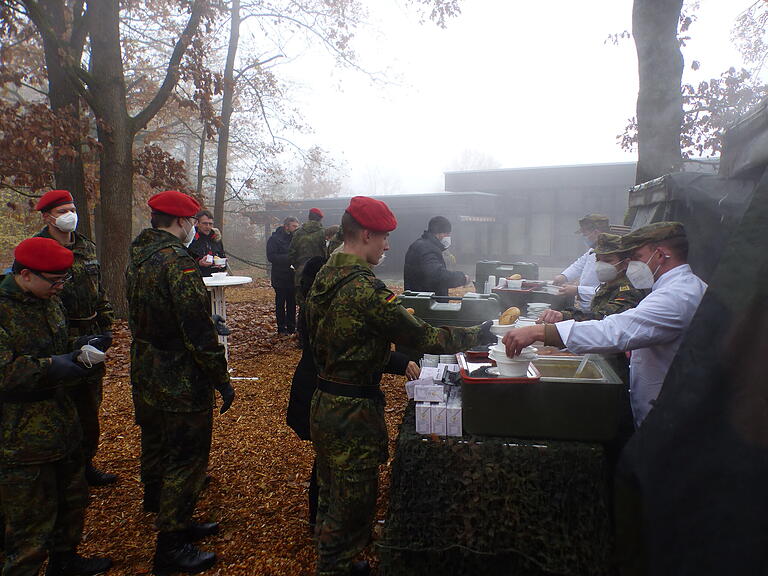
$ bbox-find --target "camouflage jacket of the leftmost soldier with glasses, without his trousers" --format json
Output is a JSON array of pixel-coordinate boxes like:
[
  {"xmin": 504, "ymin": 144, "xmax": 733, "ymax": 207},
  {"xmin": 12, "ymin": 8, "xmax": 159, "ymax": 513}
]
[{"xmin": 0, "ymin": 274, "xmax": 82, "ymax": 464}]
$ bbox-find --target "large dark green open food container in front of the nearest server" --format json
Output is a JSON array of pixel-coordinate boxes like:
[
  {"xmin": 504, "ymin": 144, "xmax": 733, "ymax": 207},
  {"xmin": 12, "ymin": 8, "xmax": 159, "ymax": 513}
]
[{"xmin": 461, "ymin": 356, "xmax": 629, "ymax": 442}]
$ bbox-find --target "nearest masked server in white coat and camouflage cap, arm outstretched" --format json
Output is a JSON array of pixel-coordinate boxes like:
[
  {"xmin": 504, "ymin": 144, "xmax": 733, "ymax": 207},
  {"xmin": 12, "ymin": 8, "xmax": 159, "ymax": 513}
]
[{"xmin": 503, "ymin": 222, "xmax": 707, "ymax": 427}]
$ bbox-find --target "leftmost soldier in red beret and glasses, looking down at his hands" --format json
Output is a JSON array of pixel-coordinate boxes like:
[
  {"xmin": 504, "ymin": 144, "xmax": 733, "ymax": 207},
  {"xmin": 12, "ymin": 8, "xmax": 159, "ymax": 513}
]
[{"xmin": 0, "ymin": 238, "xmax": 112, "ymax": 576}]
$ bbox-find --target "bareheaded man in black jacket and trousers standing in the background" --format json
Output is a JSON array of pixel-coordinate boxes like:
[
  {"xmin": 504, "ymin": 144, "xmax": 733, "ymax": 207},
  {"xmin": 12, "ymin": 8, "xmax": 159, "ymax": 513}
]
[{"xmin": 267, "ymin": 216, "xmax": 299, "ymax": 334}]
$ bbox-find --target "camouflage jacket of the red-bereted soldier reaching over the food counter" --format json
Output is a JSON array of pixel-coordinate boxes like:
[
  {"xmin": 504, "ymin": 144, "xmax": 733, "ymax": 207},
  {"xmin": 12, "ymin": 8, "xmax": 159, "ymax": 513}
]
[{"xmin": 306, "ymin": 252, "xmax": 480, "ymax": 385}]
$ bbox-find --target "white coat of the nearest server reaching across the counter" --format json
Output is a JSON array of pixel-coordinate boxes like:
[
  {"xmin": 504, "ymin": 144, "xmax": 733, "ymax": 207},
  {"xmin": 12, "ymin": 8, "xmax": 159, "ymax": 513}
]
[{"xmin": 555, "ymin": 264, "xmax": 707, "ymax": 427}]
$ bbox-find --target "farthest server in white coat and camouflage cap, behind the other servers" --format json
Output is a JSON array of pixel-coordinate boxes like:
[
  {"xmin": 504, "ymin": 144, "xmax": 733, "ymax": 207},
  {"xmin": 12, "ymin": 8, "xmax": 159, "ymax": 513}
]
[{"xmin": 552, "ymin": 214, "xmax": 611, "ymax": 310}]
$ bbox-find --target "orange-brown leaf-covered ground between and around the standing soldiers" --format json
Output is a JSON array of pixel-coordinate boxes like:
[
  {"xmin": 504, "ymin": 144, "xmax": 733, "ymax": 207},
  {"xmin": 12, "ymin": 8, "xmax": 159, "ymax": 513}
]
[{"xmin": 82, "ymin": 280, "xmax": 406, "ymax": 576}]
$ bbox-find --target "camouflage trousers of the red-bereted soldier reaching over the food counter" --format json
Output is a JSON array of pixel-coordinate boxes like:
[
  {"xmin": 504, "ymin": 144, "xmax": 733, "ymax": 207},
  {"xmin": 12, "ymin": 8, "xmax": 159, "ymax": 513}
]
[{"xmin": 310, "ymin": 390, "xmax": 387, "ymax": 576}]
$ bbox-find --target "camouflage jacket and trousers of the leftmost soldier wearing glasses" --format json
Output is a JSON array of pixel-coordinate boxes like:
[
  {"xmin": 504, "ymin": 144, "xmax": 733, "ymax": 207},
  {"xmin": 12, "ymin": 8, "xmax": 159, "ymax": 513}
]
[{"xmin": 0, "ymin": 275, "xmax": 88, "ymax": 576}]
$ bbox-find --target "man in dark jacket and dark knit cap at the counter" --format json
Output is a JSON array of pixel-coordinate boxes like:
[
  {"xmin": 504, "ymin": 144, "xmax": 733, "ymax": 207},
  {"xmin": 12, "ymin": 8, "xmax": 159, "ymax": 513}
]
[{"xmin": 403, "ymin": 216, "xmax": 469, "ymax": 296}]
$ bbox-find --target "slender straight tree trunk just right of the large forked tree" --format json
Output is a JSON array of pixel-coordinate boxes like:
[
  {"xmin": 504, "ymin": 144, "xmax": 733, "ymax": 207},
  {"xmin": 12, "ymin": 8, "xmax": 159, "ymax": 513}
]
[{"xmin": 213, "ymin": 0, "xmax": 240, "ymax": 230}]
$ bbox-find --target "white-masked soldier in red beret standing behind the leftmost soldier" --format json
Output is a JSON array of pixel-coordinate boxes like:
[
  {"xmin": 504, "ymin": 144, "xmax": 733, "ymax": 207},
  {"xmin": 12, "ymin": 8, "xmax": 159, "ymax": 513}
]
[{"xmin": 35, "ymin": 190, "xmax": 117, "ymax": 486}]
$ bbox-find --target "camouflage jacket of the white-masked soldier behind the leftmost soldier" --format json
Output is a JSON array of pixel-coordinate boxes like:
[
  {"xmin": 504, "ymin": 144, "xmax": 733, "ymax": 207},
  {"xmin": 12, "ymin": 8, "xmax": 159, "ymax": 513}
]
[{"xmin": 37, "ymin": 226, "xmax": 115, "ymax": 336}]
